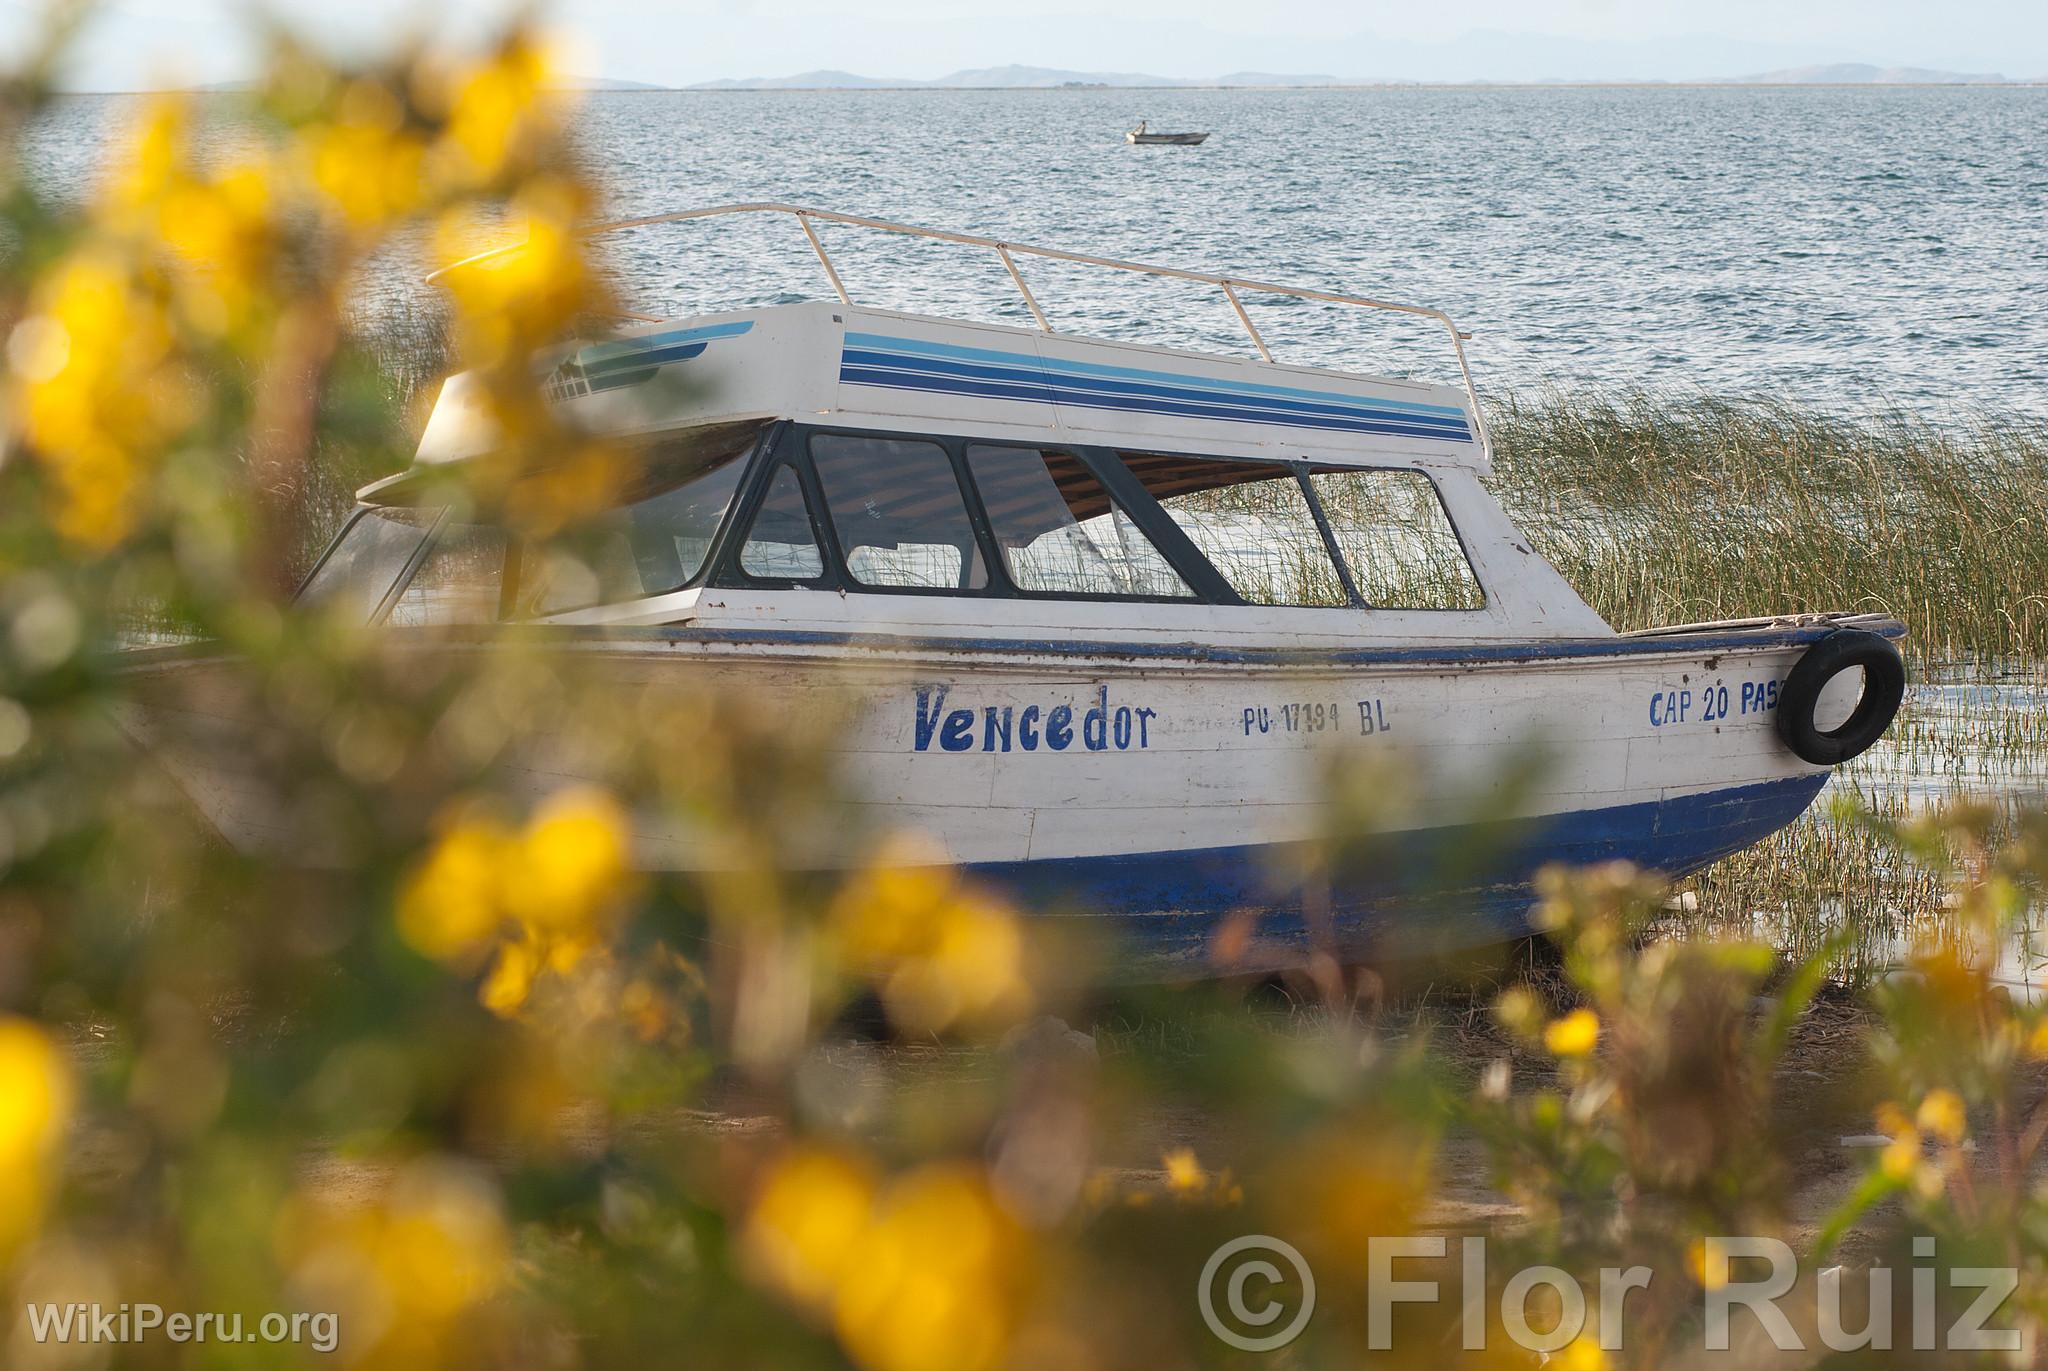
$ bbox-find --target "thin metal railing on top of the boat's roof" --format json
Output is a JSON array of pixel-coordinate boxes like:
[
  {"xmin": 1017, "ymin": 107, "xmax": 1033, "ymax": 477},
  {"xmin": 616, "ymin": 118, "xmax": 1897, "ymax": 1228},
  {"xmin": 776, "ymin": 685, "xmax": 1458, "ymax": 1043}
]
[{"xmin": 428, "ymin": 201, "xmax": 1493, "ymax": 455}]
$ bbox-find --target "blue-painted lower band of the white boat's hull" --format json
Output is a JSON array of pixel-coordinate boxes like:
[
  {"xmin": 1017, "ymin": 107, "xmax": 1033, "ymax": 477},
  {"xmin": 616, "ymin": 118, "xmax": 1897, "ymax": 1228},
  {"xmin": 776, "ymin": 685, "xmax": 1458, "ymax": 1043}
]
[{"xmin": 973, "ymin": 773, "xmax": 1827, "ymax": 967}]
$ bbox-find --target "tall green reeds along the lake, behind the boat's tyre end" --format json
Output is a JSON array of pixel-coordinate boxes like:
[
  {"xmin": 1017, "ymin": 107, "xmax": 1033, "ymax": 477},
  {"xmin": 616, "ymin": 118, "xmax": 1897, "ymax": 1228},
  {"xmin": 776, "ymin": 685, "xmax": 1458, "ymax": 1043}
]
[{"xmin": 1489, "ymin": 393, "xmax": 2048, "ymax": 660}]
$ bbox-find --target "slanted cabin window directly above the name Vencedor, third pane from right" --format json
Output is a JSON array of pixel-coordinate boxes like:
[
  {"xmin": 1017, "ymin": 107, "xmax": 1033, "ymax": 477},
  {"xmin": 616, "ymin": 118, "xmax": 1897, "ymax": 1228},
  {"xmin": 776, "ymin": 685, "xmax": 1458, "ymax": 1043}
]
[{"xmin": 967, "ymin": 443, "xmax": 1194, "ymax": 598}]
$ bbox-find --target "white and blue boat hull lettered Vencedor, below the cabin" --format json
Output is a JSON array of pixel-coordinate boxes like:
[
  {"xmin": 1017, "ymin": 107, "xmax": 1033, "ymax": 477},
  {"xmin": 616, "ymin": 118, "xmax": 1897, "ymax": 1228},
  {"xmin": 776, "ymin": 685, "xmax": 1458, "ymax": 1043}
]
[{"xmin": 108, "ymin": 627, "xmax": 1875, "ymax": 959}]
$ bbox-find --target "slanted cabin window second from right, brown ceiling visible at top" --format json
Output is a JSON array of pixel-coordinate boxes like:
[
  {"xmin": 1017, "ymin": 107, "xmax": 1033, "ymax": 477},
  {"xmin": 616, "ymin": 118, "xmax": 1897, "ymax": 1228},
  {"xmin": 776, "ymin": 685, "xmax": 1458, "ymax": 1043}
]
[{"xmin": 1122, "ymin": 453, "xmax": 1352, "ymax": 607}]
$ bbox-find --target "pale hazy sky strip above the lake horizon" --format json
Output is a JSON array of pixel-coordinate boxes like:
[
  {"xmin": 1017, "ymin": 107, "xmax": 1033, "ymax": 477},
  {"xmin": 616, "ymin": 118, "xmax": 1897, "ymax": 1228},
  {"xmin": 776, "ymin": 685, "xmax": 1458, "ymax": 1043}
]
[{"xmin": 12, "ymin": 0, "xmax": 2048, "ymax": 88}]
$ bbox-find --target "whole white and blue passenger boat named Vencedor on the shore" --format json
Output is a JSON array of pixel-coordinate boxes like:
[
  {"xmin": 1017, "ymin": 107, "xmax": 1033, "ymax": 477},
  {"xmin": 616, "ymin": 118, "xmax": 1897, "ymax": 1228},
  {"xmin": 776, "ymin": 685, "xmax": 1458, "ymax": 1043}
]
[{"xmin": 133, "ymin": 205, "xmax": 1903, "ymax": 957}]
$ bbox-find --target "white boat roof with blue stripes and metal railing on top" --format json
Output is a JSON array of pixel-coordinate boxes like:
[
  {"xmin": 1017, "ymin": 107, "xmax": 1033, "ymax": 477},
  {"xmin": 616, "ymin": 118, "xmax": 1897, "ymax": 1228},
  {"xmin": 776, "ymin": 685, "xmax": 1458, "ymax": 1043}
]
[{"xmin": 399, "ymin": 205, "xmax": 1489, "ymax": 491}]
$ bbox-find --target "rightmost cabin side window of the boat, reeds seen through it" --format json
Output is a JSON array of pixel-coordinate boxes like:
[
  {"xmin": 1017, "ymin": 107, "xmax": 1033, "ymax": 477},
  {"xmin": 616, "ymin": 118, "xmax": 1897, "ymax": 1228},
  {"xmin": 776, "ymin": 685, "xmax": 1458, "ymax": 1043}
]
[{"xmin": 1309, "ymin": 467, "xmax": 1487, "ymax": 609}]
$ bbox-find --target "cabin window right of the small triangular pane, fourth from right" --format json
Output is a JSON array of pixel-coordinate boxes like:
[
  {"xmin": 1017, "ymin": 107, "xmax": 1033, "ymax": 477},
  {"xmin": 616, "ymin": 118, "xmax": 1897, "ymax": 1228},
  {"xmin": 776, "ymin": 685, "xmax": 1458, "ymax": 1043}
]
[{"xmin": 811, "ymin": 432, "xmax": 989, "ymax": 590}]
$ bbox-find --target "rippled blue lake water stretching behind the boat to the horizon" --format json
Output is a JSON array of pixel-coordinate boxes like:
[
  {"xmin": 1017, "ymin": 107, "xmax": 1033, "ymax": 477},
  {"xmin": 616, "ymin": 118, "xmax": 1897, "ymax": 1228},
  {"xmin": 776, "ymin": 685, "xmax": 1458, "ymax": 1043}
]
[{"xmin": 37, "ymin": 88, "xmax": 2048, "ymax": 418}]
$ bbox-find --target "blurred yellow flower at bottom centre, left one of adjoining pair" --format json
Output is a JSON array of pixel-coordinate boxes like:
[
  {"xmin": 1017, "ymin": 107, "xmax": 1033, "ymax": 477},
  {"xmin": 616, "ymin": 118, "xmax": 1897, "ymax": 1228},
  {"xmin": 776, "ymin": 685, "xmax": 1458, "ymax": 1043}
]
[{"xmin": 743, "ymin": 1148, "xmax": 874, "ymax": 1312}]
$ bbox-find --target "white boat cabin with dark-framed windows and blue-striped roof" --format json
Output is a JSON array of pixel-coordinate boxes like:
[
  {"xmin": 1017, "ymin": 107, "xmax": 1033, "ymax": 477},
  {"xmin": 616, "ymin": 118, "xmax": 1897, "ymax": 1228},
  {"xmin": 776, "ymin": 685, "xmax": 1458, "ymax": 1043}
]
[{"xmin": 303, "ymin": 207, "xmax": 1612, "ymax": 648}]
